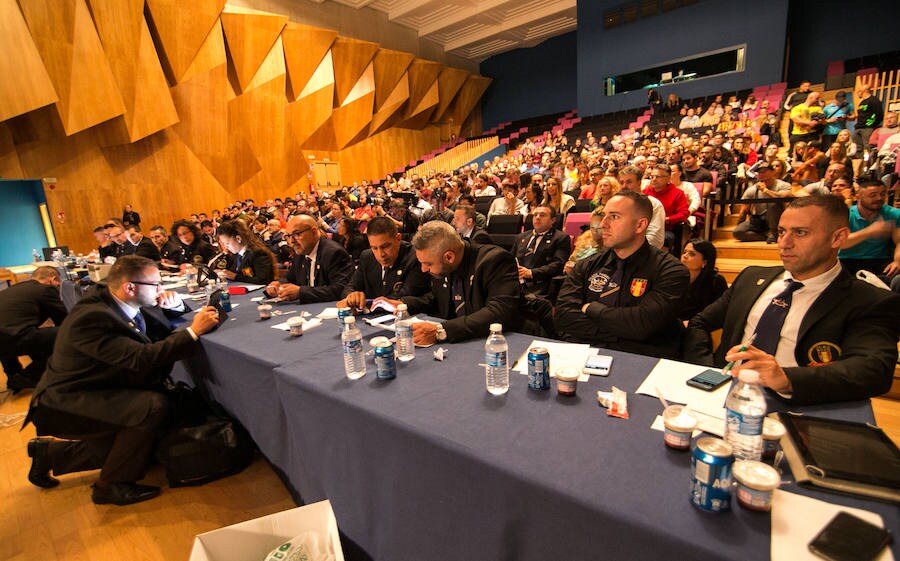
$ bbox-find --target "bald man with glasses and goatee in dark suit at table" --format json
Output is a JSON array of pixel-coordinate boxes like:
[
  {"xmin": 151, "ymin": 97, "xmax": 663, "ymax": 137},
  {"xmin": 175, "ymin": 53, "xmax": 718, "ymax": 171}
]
[{"xmin": 266, "ymin": 214, "xmax": 353, "ymax": 304}]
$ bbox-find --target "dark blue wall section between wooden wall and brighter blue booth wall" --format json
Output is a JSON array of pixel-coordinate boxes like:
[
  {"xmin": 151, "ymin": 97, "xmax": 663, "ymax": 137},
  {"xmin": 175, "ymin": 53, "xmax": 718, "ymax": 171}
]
[{"xmin": 481, "ymin": 31, "xmax": 578, "ymax": 130}]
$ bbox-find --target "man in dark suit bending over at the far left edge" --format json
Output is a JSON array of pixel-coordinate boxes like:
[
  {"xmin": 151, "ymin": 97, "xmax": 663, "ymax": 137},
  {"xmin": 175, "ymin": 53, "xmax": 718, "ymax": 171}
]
[{"xmin": 0, "ymin": 267, "xmax": 66, "ymax": 392}]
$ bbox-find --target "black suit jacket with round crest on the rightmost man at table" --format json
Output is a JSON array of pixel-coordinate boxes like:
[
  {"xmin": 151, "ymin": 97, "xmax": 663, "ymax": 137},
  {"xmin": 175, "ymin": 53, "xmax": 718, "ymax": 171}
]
[{"xmin": 685, "ymin": 267, "xmax": 900, "ymax": 404}]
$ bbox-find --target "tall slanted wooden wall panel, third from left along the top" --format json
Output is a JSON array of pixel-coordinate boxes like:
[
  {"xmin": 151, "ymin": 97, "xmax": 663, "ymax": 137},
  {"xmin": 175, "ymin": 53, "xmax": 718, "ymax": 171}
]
[{"xmin": 89, "ymin": 0, "xmax": 178, "ymax": 144}]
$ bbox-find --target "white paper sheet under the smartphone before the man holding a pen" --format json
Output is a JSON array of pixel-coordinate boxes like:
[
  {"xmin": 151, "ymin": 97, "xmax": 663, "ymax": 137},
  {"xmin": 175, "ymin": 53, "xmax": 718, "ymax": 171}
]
[{"xmin": 635, "ymin": 359, "xmax": 731, "ymax": 419}]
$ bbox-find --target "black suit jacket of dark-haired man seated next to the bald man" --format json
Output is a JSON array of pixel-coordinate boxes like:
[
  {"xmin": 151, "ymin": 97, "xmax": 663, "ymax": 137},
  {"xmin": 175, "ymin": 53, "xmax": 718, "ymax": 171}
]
[{"xmin": 341, "ymin": 242, "xmax": 431, "ymax": 300}]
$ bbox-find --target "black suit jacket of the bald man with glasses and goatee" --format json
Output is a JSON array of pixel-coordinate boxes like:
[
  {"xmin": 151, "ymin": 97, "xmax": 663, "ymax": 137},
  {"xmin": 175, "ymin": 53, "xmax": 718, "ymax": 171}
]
[{"xmin": 287, "ymin": 237, "xmax": 353, "ymax": 304}]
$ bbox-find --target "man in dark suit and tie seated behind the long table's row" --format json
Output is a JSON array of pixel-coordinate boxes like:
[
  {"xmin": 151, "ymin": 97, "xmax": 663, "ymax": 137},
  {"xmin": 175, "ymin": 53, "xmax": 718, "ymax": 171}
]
[{"xmin": 512, "ymin": 206, "xmax": 572, "ymax": 296}]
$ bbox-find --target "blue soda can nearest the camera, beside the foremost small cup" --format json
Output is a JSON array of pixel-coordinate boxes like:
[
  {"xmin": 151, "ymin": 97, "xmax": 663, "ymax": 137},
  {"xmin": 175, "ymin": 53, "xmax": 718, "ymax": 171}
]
[{"xmin": 691, "ymin": 436, "xmax": 734, "ymax": 512}]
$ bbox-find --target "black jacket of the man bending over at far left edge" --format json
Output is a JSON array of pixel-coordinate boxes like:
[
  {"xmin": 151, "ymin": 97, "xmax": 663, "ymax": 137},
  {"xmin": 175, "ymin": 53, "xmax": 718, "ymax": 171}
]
[{"xmin": 0, "ymin": 280, "xmax": 66, "ymax": 339}]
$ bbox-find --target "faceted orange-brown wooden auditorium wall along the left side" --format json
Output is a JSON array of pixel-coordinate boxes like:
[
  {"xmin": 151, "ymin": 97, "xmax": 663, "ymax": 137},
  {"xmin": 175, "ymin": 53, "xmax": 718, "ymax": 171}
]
[{"xmin": 0, "ymin": 0, "xmax": 490, "ymax": 251}]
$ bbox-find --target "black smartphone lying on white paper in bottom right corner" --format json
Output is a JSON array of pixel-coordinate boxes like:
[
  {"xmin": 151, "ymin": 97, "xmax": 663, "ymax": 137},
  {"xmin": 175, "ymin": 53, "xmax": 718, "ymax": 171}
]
[{"xmin": 809, "ymin": 511, "xmax": 893, "ymax": 561}]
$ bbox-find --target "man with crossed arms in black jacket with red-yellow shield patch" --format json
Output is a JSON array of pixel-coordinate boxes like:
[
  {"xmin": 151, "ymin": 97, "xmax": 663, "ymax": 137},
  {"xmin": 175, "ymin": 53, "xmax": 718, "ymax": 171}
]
[{"xmin": 556, "ymin": 191, "xmax": 690, "ymax": 358}]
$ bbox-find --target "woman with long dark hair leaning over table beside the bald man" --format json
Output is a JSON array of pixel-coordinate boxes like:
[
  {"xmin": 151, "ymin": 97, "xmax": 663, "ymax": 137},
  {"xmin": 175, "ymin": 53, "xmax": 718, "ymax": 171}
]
[{"xmin": 216, "ymin": 220, "xmax": 275, "ymax": 284}]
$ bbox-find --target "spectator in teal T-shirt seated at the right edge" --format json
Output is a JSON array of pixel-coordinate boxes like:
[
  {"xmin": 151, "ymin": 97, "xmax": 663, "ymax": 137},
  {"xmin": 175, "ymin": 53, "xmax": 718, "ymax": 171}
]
[{"xmin": 836, "ymin": 180, "xmax": 900, "ymax": 278}]
